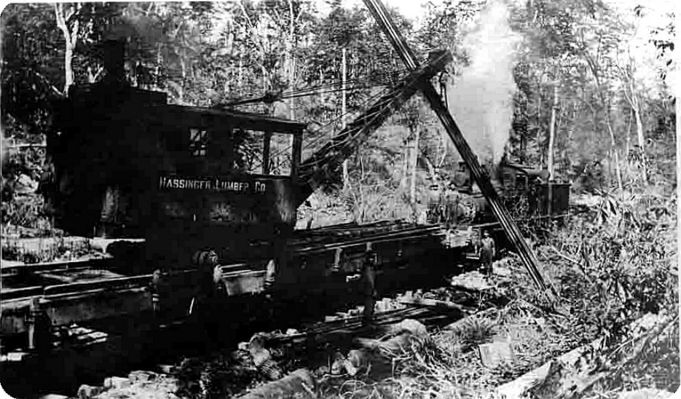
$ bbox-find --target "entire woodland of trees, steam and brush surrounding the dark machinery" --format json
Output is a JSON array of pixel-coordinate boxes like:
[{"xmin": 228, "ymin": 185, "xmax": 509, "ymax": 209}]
[{"xmin": 0, "ymin": 0, "xmax": 679, "ymax": 397}]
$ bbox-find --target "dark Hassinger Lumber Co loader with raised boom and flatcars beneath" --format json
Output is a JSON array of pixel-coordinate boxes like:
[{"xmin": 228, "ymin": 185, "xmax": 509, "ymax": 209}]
[{"xmin": 0, "ymin": 18, "xmax": 567, "ymax": 396}]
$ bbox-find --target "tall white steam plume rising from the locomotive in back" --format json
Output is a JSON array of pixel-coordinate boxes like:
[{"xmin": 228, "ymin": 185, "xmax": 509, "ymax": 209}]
[{"xmin": 447, "ymin": 0, "xmax": 520, "ymax": 165}]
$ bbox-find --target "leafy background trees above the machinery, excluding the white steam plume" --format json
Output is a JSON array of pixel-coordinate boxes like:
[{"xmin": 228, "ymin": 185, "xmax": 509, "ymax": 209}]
[{"xmin": 1, "ymin": 0, "xmax": 676, "ymax": 231}]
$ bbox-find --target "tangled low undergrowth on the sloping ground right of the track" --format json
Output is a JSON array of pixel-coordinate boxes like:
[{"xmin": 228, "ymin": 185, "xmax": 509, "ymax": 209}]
[{"xmin": 322, "ymin": 192, "xmax": 679, "ymax": 398}]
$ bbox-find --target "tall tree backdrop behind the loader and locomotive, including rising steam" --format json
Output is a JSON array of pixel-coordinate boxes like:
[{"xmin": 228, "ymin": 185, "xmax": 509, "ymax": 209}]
[{"xmin": 2, "ymin": 0, "xmax": 676, "ymax": 227}]
